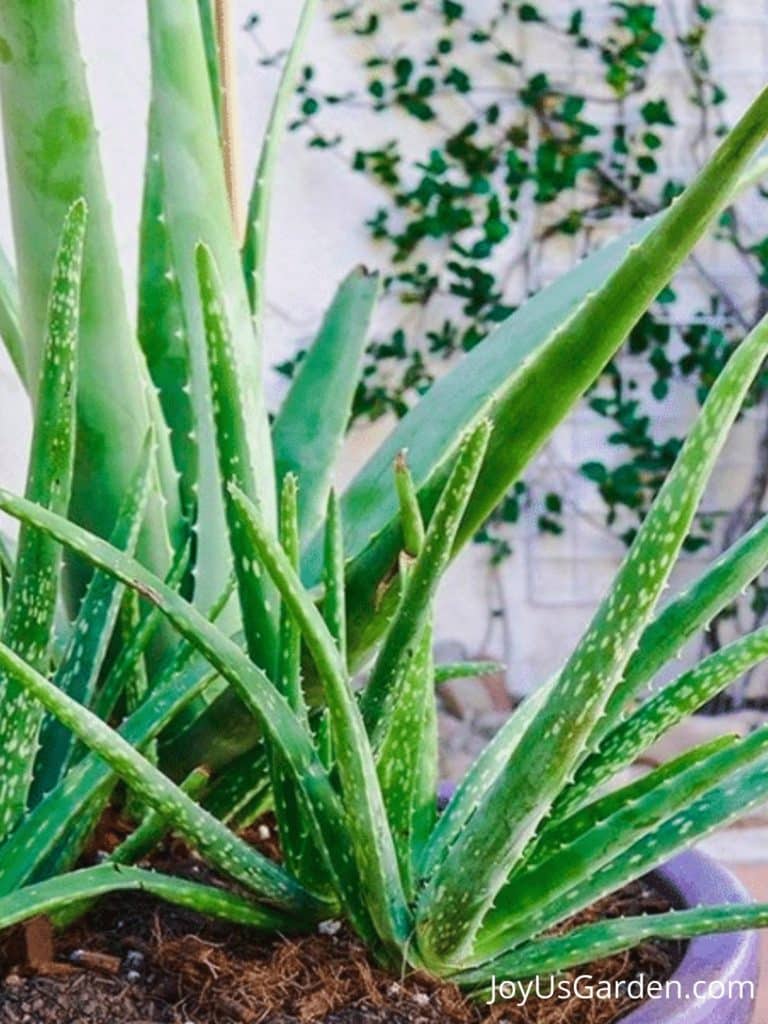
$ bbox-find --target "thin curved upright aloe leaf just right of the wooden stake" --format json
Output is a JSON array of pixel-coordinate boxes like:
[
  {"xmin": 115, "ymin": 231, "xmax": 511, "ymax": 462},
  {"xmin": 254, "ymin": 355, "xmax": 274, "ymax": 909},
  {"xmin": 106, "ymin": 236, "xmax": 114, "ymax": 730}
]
[{"xmin": 243, "ymin": 0, "xmax": 322, "ymax": 315}]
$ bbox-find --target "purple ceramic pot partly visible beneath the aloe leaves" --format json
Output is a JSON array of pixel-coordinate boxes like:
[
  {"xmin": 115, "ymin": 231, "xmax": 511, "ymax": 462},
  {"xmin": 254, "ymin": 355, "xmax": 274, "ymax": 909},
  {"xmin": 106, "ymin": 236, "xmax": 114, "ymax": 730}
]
[{"xmin": 623, "ymin": 851, "xmax": 762, "ymax": 1024}]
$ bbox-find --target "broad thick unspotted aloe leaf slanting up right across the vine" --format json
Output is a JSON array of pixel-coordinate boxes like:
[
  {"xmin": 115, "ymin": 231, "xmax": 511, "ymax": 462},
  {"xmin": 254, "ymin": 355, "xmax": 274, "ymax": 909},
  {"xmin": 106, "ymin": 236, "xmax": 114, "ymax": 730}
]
[{"xmin": 305, "ymin": 91, "xmax": 768, "ymax": 664}]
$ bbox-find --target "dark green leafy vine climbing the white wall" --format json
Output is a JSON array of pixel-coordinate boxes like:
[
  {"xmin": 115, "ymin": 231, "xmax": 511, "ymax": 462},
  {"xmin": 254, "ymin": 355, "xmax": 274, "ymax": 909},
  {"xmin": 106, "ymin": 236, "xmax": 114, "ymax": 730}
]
[{"xmin": 248, "ymin": 0, "xmax": 768, "ymax": 696}]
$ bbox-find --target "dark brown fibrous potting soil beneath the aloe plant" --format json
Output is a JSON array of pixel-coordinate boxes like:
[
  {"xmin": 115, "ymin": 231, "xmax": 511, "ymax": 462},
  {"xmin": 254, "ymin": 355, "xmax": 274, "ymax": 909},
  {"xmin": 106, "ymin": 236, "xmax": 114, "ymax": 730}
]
[{"xmin": 0, "ymin": 823, "xmax": 681, "ymax": 1024}]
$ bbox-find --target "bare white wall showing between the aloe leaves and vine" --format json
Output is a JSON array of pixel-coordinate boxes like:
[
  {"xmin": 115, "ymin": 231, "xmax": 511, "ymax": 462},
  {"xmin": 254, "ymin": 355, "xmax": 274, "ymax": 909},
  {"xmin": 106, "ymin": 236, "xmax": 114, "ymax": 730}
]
[{"xmin": 0, "ymin": 0, "xmax": 768, "ymax": 690}]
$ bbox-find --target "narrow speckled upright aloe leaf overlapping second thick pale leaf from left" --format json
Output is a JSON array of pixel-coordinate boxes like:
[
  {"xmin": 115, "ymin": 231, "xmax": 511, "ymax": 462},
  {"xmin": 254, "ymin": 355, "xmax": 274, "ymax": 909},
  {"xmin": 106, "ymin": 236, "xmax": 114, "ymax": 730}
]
[{"xmin": 197, "ymin": 245, "xmax": 276, "ymax": 673}]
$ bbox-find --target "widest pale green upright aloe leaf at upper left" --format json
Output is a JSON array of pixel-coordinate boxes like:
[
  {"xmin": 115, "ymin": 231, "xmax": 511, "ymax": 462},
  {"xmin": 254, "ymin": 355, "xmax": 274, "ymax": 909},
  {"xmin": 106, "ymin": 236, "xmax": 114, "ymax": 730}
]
[{"xmin": 0, "ymin": 0, "xmax": 178, "ymax": 600}]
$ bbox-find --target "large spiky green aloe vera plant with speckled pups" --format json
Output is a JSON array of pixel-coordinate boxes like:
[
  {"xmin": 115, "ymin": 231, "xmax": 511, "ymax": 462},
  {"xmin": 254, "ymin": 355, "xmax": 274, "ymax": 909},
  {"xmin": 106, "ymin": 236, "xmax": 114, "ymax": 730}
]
[{"xmin": 0, "ymin": 0, "xmax": 768, "ymax": 991}]
